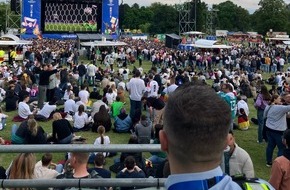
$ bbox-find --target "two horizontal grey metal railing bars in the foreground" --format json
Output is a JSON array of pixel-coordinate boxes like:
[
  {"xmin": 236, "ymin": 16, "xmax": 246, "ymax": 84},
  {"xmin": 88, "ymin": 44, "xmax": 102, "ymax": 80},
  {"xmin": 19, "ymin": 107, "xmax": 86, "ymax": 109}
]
[{"xmin": 0, "ymin": 144, "xmax": 166, "ymax": 189}]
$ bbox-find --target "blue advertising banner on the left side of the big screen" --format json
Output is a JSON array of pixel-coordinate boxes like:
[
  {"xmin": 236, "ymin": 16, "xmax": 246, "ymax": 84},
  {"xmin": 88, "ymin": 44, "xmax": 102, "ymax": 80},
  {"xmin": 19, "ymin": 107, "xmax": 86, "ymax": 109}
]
[{"xmin": 21, "ymin": 0, "xmax": 41, "ymax": 35}]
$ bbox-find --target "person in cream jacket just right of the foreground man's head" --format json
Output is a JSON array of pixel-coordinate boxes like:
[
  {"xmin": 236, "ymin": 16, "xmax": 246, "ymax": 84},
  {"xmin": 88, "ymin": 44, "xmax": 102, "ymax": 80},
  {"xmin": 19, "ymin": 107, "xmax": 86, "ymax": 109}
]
[{"xmin": 228, "ymin": 131, "xmax": 255, "ymax": 178}]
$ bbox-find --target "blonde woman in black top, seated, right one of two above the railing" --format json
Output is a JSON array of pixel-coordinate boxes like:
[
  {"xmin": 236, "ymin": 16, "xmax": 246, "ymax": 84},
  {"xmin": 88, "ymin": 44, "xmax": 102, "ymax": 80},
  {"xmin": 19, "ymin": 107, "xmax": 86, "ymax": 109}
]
[{"xmin": 52, "ymin": 112, "xmax": 74, "ymax": 144}]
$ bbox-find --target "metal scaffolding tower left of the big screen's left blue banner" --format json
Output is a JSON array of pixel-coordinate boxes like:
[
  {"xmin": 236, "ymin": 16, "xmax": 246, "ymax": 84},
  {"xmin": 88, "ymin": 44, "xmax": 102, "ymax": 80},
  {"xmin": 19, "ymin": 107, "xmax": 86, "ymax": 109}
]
[{"xmin": 6, "ymin": 0, "xmax": 22, "ymax": 32}]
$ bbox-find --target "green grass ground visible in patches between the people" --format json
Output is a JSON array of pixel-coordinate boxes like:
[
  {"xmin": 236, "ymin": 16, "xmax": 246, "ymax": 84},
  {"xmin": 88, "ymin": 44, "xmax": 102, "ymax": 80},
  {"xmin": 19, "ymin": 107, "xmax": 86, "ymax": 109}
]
[{"xmin": 0, "ymin": 61, "xmax": 276, "ymax": 180}]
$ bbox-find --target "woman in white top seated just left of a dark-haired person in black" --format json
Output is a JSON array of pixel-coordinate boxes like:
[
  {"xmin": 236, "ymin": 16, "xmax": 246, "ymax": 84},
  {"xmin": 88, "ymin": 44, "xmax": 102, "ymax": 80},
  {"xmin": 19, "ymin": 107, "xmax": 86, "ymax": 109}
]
[{"xmin": 73, "ymin": 104, "xmax": 90, "ymax": 132}]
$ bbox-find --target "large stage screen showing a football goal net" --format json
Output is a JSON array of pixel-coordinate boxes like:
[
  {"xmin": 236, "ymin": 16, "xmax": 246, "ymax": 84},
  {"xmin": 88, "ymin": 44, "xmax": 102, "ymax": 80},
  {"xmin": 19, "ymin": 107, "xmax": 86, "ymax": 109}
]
[{"xmin": 42, "ymin": 1, "xmax": 102, "ymax": 32}]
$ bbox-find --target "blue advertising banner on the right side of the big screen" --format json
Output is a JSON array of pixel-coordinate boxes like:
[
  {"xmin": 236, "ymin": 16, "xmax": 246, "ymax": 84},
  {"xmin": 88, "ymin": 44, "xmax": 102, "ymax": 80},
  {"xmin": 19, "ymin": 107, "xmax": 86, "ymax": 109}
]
[{"xmin": 102, "ymin": 0, "xmax": 119, "ymax": 35}]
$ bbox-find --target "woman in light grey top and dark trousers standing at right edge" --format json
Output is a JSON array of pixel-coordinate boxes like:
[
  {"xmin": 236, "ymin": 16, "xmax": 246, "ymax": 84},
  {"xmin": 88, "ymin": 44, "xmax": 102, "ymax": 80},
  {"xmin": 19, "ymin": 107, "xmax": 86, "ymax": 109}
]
[{"xmin": 263, "ymin": 95, "xmax": 290, "ymax": 167}]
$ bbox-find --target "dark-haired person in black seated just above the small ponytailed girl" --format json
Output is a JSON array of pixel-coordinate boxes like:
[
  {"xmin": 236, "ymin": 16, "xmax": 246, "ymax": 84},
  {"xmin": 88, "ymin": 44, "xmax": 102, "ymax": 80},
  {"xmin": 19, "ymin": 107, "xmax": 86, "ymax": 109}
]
[{"xmin": 92, "ymin": 105, "xmax": 112, "ymax": 132}]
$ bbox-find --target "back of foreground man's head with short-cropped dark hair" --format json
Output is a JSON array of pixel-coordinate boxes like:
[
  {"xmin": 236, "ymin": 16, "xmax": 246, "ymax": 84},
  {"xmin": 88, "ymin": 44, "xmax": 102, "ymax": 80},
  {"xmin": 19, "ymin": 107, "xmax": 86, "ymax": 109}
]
[{"xmin": 160, "ymin": 82, "xmax": 231, "ymax": 165}]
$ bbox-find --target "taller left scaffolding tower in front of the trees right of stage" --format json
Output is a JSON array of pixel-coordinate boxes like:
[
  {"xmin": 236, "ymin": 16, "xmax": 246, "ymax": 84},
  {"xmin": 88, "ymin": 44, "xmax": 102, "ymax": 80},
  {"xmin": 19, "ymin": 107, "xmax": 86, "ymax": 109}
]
[{"xmin": 179, "ymin": 0, "xmax": 197, "ymax": 35}]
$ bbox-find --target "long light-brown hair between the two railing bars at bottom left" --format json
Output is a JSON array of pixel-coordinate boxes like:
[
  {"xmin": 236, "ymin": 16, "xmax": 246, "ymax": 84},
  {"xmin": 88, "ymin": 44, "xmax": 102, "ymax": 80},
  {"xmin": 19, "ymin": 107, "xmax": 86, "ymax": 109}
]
[{"xmin": 9, "ymin": 153, "xmax": 36, "ymax": 179}]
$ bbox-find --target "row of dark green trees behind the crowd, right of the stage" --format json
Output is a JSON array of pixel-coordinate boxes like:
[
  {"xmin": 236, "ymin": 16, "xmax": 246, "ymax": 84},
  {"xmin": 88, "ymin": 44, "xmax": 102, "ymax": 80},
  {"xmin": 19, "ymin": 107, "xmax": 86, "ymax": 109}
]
[{"xmin": 120, "ymin": 0, "xmax": 290, "ymax": 34}]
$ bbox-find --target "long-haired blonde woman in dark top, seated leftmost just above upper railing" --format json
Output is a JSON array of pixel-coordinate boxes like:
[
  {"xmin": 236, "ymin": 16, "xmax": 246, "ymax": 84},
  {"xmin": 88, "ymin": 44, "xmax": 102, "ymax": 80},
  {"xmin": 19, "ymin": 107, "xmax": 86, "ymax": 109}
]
[{"xmin": 25, "ymin": 119, "xmax": 47, "ymax": 144}]
